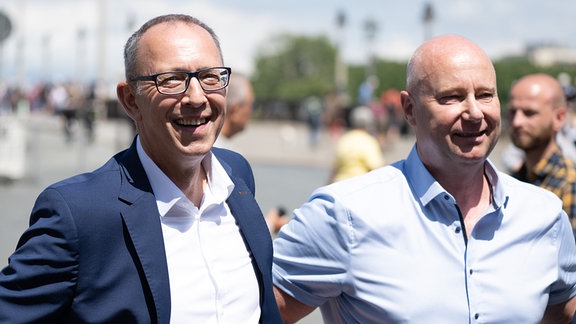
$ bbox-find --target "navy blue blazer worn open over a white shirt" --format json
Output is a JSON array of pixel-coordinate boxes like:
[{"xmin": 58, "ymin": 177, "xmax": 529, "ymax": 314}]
[{"xmin": 0, "ymin": 141, "xmax": 282, "ymax": 324}]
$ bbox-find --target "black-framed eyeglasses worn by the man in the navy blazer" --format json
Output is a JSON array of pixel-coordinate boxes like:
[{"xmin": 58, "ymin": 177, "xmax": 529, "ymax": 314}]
[{"xmin": 131, "ymin": 67, "xmax": 232, "ymax": 95}]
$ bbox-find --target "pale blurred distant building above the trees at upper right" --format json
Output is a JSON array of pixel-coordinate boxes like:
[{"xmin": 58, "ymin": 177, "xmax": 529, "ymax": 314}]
[{"xmin": 526, "ymin": 44, "xmax": 576, "ymax": 67}]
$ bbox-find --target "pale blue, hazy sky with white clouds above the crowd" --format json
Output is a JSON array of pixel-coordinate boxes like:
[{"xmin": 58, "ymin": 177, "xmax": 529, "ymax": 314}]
[{"xmin": 0, "ymin": 0, "xmax": 576, "ymax": 90}]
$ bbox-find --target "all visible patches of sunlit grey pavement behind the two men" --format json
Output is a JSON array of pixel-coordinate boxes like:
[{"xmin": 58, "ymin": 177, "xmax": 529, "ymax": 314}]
[{"xmin": 0, "ymin": 114, "xmax": 507, "ymax": 324}]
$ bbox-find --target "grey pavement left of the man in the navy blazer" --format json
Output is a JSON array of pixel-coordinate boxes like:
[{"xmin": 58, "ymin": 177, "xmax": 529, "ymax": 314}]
[{"xmin": 0, "ymin": 115, "xmax": 136, "ymax": 267}]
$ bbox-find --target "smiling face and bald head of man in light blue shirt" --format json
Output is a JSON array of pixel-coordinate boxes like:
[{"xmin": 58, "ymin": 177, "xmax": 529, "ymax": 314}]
[{"xmin": 403, "ymin": 37, "xmax": 500, "ymax": 170}]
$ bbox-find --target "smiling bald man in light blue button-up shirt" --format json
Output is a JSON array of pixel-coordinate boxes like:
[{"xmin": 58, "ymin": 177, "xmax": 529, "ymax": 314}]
[{"xmin": 272, "ymin": 35, "xmax": 576, "ymax": 323}]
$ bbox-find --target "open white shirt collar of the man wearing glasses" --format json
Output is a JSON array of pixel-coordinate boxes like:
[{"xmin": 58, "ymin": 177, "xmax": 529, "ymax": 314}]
[{"xmin": 136, "ymin": 136, "xmax": 234, "ymax": 217}]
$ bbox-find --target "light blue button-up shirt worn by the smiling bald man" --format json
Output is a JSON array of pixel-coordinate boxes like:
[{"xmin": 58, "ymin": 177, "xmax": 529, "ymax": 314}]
[{"xmin": 273, "ymin": 148, "xmax": 576, "ymax": 324}]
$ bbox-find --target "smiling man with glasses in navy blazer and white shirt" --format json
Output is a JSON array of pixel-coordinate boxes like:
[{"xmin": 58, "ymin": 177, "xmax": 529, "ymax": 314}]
[{"xmin": 0, "ymin": 15, "xmax": 281, "ymax": 323}]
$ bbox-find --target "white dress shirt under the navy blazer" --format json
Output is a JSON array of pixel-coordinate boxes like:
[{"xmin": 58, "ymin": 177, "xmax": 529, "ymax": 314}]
[{"xmin": 137, "ymin": 138, "xmax": 260, "ymax": 323}]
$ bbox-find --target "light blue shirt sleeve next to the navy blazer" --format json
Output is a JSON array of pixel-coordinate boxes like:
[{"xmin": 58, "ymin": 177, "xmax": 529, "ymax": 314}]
[{"xmin": 272, "ymin": 189, "xmax": 354, "ymax": 307}]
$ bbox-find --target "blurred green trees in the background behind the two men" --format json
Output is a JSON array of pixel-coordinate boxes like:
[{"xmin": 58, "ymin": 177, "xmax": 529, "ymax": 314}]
[{"xmin": 252, "ymin": 34, "xmax": 576, "ymax": 119}]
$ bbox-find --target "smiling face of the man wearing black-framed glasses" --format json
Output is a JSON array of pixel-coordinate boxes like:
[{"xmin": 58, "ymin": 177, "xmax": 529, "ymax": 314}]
[{"xmin": 124, "ymin": 22, "xmax": 226, "ymax": 172}]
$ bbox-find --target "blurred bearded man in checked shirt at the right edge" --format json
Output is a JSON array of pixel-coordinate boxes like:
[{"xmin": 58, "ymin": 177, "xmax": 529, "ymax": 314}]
[{"xmin": 508, "ymin": 74, "xmax": 576, "ymax": 229}]
